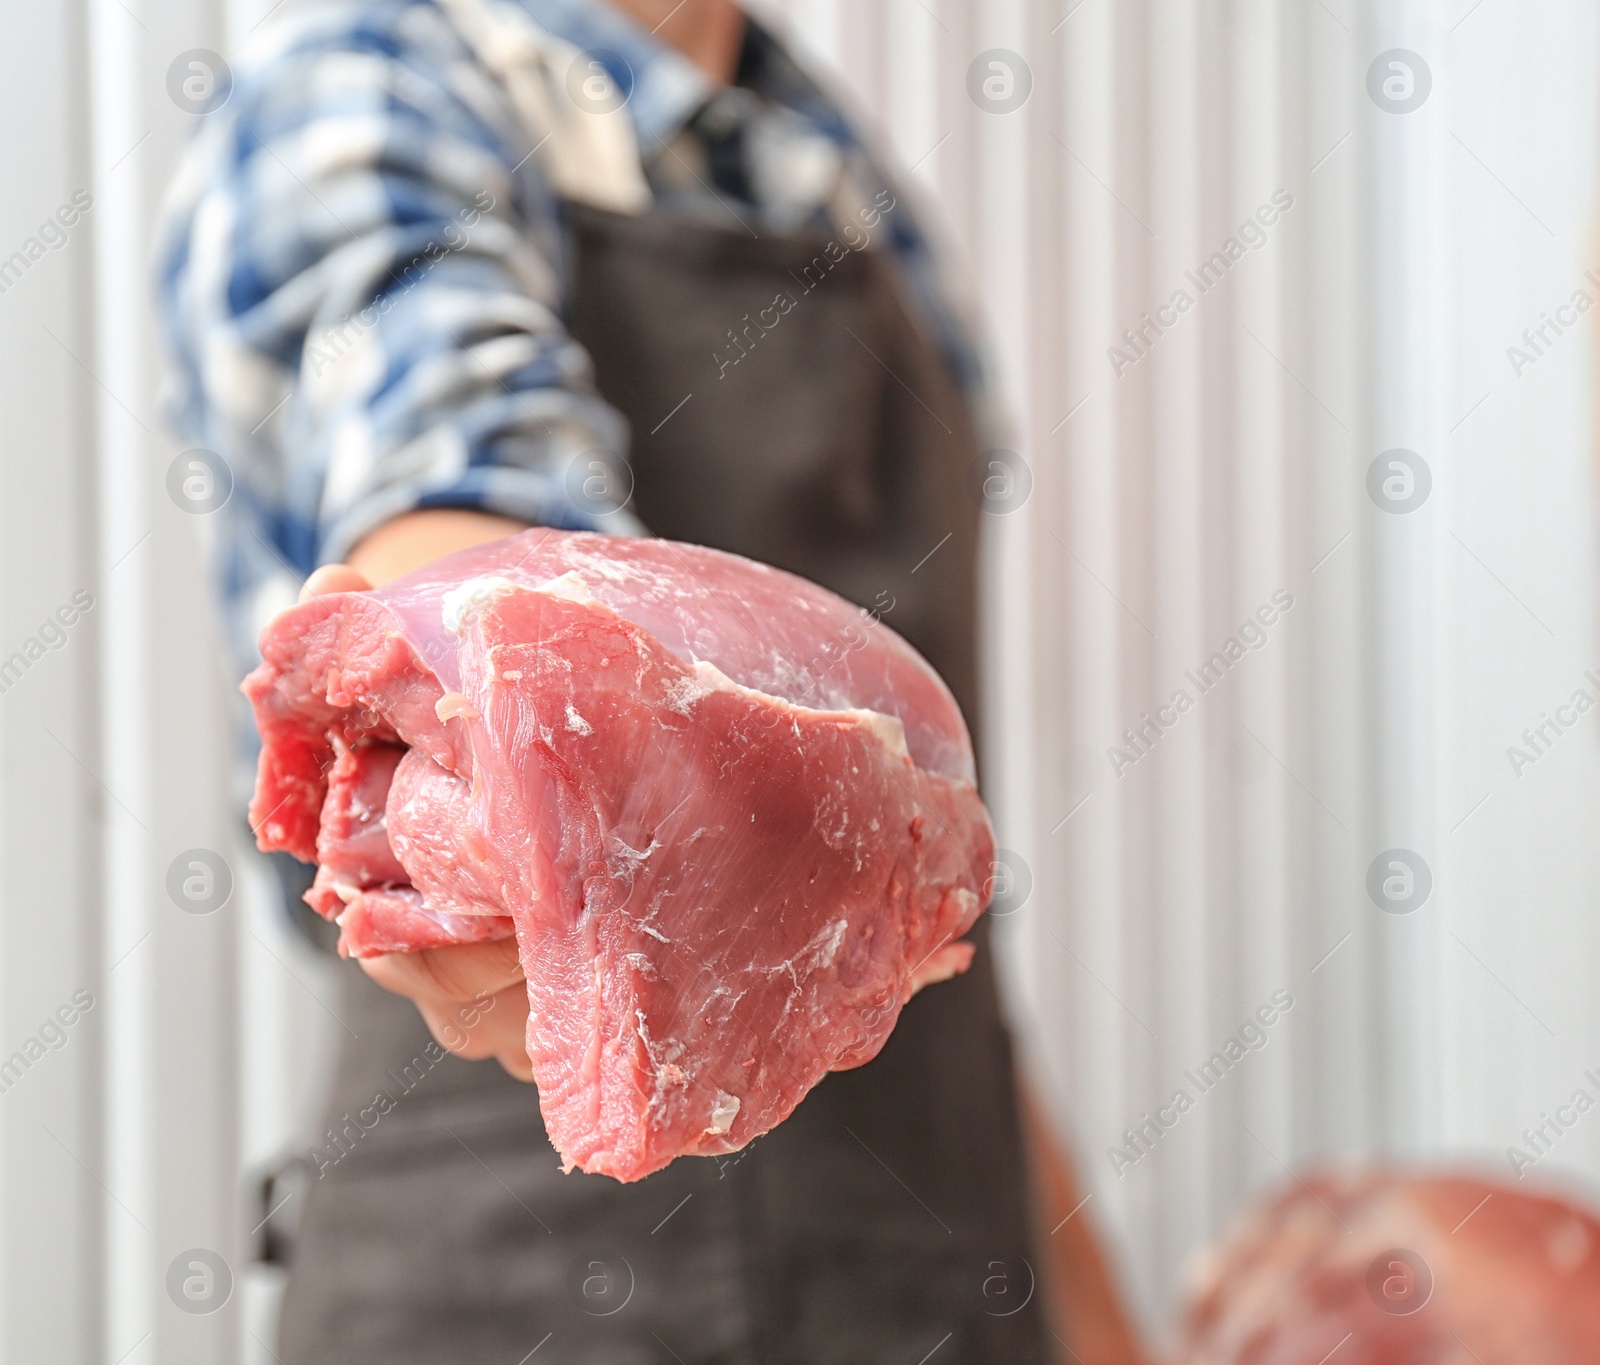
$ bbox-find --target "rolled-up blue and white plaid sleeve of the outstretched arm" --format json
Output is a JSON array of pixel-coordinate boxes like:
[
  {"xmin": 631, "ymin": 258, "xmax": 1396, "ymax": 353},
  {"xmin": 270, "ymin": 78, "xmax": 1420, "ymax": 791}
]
[{"xmin": 160, "ymin": 0, "xmax": 637, "ymax": 574}]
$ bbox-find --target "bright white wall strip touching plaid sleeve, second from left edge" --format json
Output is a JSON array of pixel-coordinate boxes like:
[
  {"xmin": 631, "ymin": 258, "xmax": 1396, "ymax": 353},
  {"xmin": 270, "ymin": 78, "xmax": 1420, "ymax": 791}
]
[{"xmin": 90, "ymin": 0, "xmax": 243, "ymax": 1362}]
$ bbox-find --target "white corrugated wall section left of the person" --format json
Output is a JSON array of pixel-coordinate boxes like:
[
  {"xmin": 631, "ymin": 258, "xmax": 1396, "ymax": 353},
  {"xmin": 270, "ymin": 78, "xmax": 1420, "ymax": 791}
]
[{"xmin": 0, "ymin": 0, "xmax": 345, "ymax": 1365}]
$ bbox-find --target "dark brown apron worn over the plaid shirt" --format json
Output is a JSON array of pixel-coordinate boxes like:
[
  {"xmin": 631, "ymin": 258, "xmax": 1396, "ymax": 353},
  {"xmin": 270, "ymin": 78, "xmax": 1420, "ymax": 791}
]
[{"xmin": 280, "ymin": 208, "xmax": 1048, "ymax": 1365}]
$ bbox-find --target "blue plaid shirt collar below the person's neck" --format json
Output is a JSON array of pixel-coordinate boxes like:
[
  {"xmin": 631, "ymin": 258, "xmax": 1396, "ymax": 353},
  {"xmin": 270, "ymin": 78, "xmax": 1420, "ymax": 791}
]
[{"xmin": 520, "ymin": 0, "xmax": 717, "ymax": 148}]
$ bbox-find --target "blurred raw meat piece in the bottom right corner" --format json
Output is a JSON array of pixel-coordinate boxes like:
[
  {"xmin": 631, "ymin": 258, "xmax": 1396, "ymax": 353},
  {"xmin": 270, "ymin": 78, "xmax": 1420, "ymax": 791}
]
[{"xmin": 1174, "ymin": 1173, "xmax": 1600, "ymax": 1365}]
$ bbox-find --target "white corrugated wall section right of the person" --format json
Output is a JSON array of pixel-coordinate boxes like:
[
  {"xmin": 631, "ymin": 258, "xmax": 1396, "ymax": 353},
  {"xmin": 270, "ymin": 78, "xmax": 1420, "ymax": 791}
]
[{"xmin": 758, "ymin": 0, "xmax": 1600, "ymax": 1323}]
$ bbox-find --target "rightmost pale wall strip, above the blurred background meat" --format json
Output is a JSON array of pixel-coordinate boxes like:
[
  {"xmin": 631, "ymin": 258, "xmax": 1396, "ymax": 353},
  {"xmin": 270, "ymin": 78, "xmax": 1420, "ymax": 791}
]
[{"xmin": 1429, "ymin": 3, "xmax": 1600, "ymax": 1216}]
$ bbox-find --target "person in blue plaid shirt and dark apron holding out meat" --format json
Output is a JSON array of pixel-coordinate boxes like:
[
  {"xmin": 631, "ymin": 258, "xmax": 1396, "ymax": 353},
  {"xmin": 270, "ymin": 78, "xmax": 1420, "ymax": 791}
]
[{"xmin": 160, "ymin": 0, "xmax": 1138, "ymax": 1365}]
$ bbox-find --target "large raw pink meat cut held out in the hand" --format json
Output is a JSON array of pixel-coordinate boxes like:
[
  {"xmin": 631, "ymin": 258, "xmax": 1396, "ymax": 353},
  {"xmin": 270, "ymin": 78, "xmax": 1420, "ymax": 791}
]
[{"xmin": 245, "ymin": 531, "xmax": 994, "ymax": 1179}]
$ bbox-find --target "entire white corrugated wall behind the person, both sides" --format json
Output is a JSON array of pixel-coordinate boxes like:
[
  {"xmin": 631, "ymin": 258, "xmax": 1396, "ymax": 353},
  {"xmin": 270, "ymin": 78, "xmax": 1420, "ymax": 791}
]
[{"xmin": 9, "ymin": 0, "xmax": 1600, "ymax": 1365}]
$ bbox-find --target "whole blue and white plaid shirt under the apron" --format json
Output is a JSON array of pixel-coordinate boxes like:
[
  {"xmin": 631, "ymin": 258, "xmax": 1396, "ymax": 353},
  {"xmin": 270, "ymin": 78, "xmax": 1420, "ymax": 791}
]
[{"xmin": 160, "ymin": 0, "xmax": 992, "ymax": 666}]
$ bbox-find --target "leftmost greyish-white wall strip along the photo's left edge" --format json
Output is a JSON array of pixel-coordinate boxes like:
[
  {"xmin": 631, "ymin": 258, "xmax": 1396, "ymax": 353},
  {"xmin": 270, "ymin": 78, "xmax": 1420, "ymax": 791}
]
[{"xmin": 0, "ymin": 3, "xmax": 103, "ymax": 1365}]
